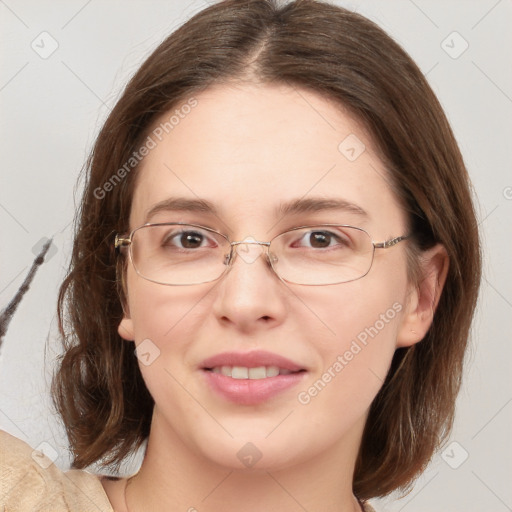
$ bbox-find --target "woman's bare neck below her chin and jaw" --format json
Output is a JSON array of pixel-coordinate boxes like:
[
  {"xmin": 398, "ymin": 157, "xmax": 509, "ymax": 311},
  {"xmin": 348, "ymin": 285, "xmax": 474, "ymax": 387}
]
[{"xmin": 125, "ymin": 406, "xmax": 364, "ymax": 512}]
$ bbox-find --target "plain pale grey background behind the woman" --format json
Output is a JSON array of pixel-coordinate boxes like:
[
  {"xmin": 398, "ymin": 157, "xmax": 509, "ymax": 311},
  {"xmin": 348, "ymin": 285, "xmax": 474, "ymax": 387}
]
[{"xmin": 0, "ymin": 0, "xmax": 512, "ymax": 512}]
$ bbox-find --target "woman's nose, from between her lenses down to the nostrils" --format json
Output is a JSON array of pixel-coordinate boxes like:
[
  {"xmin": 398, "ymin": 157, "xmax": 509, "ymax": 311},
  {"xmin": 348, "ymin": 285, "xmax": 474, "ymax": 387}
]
[{"xmin": 213, "ymin": 239, "xmax": 287, "ymax": 333}]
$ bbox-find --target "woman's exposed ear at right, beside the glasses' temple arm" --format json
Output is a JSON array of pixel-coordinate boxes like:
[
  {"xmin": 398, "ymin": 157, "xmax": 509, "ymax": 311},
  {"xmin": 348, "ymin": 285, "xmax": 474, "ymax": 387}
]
[{"xmin": 396, "ymin": 244, "xmax": 449, "ymax": 348}]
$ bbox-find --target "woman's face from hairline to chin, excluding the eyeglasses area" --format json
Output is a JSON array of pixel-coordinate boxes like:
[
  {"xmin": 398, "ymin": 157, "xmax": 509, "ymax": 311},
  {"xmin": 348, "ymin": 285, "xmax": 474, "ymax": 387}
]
[{"xmin": 119, "ymin": 84, "xmax": 416, "ymax": 469}]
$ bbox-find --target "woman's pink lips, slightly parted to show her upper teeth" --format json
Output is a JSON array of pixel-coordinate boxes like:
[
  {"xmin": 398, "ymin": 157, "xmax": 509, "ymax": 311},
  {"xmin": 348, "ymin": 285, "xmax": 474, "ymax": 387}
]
[{"xmin": 201, "ymin": 351, "xmax": 307, "ymax": 405}]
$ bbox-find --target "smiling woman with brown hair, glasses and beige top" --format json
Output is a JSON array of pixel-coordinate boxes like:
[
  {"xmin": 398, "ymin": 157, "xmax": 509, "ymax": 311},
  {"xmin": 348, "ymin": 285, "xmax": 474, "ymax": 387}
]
[{"xmin": 2, "ymin": 0, "xmax": 480, "ymax": 512}]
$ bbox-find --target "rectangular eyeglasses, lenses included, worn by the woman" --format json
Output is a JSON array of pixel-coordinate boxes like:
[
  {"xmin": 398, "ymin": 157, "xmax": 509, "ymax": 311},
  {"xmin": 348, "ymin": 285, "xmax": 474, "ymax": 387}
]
[{"xmin": 115, "ymin": 223, "xmax": 409, "ymax": 286}]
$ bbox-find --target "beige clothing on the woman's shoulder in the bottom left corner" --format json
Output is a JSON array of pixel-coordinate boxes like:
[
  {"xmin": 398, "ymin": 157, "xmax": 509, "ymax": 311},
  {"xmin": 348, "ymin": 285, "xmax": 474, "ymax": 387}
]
[{"xmin": 0, "ymin": 430, "xmax": 113, "ymax": 512}]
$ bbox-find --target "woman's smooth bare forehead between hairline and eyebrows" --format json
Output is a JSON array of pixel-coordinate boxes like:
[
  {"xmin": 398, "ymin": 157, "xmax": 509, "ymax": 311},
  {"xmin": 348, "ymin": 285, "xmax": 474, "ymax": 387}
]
[{"xmin": 130, "ymin": 84, "xmax": 403, "ymax": 234}]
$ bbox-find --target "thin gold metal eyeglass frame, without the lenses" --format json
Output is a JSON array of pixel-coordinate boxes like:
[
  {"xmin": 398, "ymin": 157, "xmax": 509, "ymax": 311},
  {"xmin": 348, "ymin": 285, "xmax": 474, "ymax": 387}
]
[{"xmin": 114, "ymin": 222, "xmax": 411, "ymax": 286}]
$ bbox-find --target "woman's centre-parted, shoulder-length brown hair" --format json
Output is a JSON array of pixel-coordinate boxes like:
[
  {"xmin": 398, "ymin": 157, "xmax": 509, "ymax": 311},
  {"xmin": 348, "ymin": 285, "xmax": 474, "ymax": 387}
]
[{"xmin": 52, "ymin": 0, "xmax": 481, "ymax": 499}]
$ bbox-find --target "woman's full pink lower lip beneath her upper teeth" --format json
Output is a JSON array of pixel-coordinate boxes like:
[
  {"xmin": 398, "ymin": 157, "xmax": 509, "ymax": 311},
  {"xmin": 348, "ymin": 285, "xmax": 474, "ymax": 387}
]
[{"xmin": 203, "ymin": 370, "xmax": 307, "ymax": 405}]
